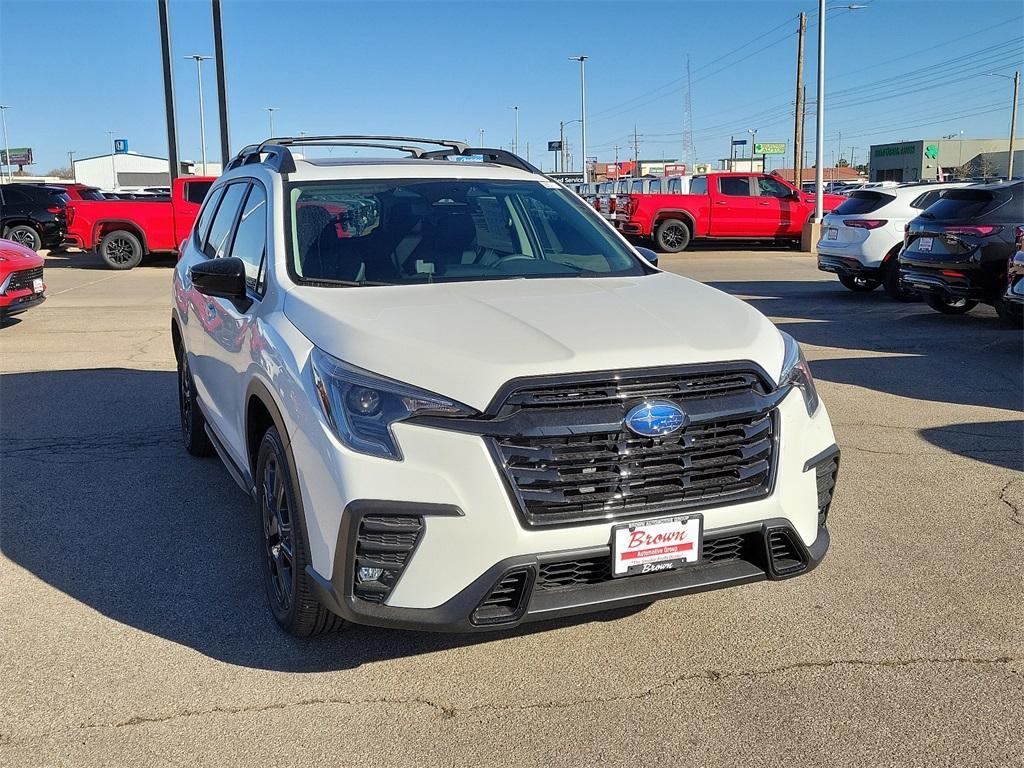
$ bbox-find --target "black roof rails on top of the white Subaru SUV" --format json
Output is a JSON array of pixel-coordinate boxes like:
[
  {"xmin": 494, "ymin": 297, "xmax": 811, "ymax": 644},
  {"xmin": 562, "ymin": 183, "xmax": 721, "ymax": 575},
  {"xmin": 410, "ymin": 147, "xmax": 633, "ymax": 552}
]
[{"xmin": 224, "ymin": 135, "xmax": 541, "ymax": 173}]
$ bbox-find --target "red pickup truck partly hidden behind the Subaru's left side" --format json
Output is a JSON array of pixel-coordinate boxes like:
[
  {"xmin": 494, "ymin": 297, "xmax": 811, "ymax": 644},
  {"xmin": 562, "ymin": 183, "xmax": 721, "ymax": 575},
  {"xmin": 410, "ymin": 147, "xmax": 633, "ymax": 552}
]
[{"xmin": 67, "ymin": 176, "xmax": 215, "ymax": 269}]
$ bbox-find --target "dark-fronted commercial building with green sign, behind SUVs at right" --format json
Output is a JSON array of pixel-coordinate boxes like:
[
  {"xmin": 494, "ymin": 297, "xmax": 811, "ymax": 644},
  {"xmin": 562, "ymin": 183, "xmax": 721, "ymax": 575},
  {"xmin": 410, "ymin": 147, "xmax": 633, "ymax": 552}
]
[{"xmin": 868, "ymin": 136, "xmax": 1022, "ymax": 181}]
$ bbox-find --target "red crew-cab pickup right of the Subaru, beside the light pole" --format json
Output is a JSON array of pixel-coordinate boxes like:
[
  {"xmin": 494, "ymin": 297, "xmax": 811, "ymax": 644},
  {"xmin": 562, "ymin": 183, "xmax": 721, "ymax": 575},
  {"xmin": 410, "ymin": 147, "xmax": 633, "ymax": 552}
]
[{"xmin": 615, "ymin": 172, "xmax": 846, "ymax": 253}]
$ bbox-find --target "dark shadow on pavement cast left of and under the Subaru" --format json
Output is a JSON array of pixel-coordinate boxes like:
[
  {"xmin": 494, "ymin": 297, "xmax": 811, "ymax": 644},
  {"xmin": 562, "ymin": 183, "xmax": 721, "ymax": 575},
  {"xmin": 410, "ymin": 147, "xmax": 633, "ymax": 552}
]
[{"xmin": 0, "ymin": 369, "xmax": 639, "ymax": 672}]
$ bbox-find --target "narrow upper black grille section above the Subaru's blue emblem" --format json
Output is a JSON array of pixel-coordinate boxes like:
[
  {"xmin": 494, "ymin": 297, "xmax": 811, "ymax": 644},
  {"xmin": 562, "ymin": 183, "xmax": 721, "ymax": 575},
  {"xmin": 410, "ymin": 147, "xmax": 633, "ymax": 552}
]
[{"xmin": 505, "ymin": 371, "xmax": 765, "ymax": 409}]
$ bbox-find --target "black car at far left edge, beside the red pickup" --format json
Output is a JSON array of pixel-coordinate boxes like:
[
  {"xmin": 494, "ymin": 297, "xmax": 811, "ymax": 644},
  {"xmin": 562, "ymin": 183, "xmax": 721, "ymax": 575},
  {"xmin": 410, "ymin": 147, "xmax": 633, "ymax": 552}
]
[{"xmin": 0, "ymin": 183, "xmax": 69, "ymax": 251}]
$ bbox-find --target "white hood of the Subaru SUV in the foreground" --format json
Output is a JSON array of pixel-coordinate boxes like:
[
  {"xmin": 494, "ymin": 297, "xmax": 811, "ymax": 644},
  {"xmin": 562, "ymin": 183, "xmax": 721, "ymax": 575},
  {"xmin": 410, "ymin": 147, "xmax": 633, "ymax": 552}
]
[{"xmin": 285, "ymin": 272, "xmax": 782, "ymax": 410}]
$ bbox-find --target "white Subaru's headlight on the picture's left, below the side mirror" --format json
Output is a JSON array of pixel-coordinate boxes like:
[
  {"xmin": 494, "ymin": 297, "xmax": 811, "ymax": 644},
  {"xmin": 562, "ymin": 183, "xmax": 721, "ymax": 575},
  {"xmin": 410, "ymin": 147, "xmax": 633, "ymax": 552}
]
[{"xmin": 310, "ymin": 348, "xmax": 474, "ymax": 461}]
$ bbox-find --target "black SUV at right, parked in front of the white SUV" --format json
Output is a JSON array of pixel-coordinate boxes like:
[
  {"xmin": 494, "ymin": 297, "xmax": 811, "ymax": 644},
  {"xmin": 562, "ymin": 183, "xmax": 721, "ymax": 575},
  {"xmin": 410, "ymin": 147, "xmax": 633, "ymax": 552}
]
[{"xmin": 899, "ymin": 181, "xmax": 1024, "ymax": 321}]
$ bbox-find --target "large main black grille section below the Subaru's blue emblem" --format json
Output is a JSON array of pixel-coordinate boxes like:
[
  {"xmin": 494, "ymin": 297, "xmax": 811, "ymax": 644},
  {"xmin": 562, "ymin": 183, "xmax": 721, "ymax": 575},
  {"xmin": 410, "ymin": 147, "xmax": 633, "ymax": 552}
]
[{"xmin": 493, "ymin": 413, "xmax": 774, "ymax": 525}]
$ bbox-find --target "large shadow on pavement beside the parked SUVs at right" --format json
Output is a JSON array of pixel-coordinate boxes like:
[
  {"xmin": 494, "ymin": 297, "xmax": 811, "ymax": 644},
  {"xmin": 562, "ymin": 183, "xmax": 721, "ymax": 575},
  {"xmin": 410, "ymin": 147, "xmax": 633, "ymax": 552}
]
[{"xmin": 710, "ymin": 281, "xmax": 1024, "ymax": 411}]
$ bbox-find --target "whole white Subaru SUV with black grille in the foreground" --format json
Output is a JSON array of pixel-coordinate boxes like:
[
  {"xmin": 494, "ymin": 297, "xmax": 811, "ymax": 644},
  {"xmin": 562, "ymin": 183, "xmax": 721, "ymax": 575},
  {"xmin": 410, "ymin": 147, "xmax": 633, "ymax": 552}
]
[{"xmin": 171, "ymin": 136, "xmax": 839, "ymax": 635}]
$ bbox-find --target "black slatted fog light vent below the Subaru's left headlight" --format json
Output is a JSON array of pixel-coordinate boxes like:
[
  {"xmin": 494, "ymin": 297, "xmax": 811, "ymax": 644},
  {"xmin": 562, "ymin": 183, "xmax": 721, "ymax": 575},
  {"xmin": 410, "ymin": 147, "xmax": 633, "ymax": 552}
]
[{"xmin": 352, "ymin": 515, "xmax": 423, "ymax": 603}]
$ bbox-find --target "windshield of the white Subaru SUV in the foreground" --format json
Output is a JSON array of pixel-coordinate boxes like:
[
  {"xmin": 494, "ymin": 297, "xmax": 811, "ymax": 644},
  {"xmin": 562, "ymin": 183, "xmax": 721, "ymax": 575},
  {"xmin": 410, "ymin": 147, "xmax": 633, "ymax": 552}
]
[{"xmin": 290, "ymin": 179, "xmax": 648, "ymax": 285}]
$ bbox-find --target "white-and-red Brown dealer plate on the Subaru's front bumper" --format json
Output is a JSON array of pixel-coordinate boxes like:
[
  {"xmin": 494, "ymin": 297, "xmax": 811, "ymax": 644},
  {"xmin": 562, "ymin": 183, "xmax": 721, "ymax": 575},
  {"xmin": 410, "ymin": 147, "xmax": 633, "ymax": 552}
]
[{"xmin": 611, "ymin": 515, "xmax": 703, "ymax": 577}]
